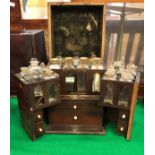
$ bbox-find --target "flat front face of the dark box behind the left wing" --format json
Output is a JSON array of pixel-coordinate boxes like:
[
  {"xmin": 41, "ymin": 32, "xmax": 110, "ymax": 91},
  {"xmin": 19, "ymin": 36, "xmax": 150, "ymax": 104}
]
[{"xmin": 10, "ymin": 34, "xmax": 33, "ymax": 94}]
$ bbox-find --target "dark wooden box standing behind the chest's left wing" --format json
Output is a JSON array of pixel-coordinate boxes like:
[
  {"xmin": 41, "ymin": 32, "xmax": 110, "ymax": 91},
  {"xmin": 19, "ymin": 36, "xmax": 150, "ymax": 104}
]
[{"xmin": 10, "ymin": 30, "xmax": 47, "ymax": 95}]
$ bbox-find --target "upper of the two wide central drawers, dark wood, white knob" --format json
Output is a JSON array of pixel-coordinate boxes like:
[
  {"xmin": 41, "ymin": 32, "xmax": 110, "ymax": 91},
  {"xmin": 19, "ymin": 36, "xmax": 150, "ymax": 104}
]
[{"xmin": 50, "ymin": 101, "xmax": 100, "ymax": 110}]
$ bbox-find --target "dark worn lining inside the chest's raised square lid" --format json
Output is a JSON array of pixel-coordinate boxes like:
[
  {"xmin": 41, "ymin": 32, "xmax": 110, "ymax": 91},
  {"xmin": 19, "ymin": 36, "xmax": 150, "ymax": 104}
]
[{"xmin": 50, "ymin": 5, "xmax": 103, "ymax": 57}]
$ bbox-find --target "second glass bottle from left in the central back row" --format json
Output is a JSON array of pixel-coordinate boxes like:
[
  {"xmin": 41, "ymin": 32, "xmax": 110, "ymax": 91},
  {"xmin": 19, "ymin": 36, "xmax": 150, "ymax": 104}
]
[{"xmin": 62, "ymin": 57, "xmax": 75, "ymax": 69}]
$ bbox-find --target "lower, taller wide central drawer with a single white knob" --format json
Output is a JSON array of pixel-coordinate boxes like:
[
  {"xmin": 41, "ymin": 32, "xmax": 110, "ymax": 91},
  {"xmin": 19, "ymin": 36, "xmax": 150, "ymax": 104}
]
[{"xmin": 48, "ymin": 110, "xmax": 102, "ymax": 125}]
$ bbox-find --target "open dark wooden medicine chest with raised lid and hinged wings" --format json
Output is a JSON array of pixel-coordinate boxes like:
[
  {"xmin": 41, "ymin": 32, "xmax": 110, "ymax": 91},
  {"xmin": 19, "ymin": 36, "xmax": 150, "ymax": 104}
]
[{"xmin": 15, "ymin": 2, "xmax": 139, "ymax": 140}]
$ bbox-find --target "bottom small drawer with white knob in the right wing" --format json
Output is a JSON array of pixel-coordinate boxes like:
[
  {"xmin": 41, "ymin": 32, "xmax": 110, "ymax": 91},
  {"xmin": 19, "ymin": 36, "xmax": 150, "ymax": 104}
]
[{"xmin": 117, "ymin": 121, "xmax": 128, "ymax": 135}]
